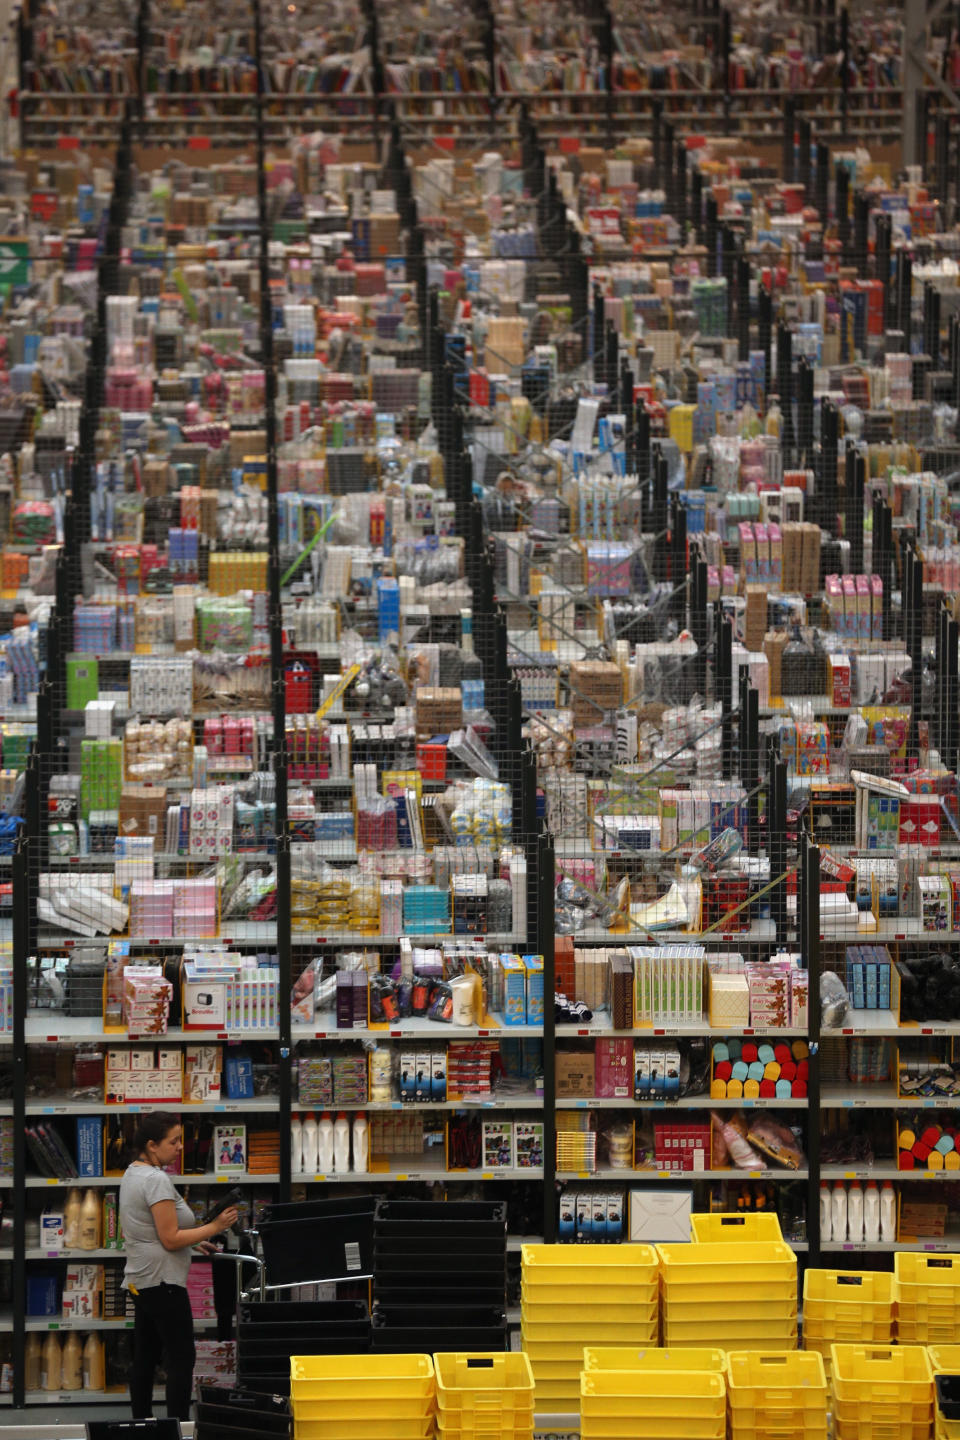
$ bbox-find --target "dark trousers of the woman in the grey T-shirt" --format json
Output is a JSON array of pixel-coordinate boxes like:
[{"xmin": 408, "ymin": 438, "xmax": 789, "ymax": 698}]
[{"xmin": 130, "ymin": 1284, "xmax": 197, "ymax": 1420}]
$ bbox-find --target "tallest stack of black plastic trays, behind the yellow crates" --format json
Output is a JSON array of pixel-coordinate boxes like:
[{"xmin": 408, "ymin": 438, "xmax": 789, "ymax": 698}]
[{"xmin": 373, "ymin": 1200, "xmax": 508, "ymax": 1355}]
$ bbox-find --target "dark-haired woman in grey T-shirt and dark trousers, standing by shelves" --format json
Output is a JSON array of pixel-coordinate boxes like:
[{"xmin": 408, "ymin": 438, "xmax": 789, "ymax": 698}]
[{"xmin": 119, "ymin": 1110, "xmax": 237, "ymax": 1420}]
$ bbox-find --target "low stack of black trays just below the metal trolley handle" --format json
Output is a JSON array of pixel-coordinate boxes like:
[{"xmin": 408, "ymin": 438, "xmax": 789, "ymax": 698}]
[{"xmin": 236, "ymin": 1300, "xmax": 370, "ymax": 1395}]
